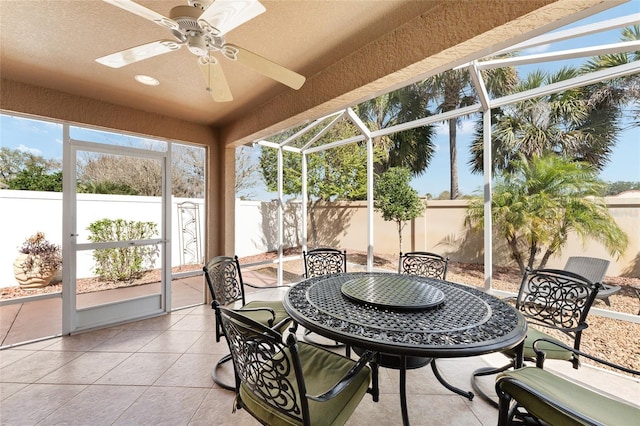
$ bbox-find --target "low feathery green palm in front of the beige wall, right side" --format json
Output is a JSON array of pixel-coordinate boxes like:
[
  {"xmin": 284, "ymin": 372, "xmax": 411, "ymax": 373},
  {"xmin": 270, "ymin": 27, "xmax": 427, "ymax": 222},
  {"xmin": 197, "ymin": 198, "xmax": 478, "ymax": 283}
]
[{"xmin": 466, "ymin": 154, "xmax": 628, "ymax": 272}]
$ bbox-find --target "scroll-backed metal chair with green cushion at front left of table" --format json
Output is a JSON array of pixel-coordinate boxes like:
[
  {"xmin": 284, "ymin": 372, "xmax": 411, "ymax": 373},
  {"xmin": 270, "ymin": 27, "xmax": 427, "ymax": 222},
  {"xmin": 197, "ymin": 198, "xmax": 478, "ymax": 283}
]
[{"xmin": 216, "ymin": 306, "xmax": 373, "ymax": 425}]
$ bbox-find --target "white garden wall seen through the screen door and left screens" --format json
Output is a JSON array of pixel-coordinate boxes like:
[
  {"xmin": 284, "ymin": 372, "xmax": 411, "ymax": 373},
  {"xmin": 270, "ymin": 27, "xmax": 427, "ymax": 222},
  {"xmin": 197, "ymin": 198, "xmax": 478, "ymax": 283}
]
[{"xmin": 0, "ymin": 190, "xmax": 205, "ymax": 287}]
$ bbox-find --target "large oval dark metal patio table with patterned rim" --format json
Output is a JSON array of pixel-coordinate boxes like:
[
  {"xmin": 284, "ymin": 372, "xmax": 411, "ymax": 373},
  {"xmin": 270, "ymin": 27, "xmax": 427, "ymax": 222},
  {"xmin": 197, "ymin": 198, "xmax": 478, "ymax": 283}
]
[{"xmin": 283, "ymin": 272, "xmax": 527, "ymax": 424}]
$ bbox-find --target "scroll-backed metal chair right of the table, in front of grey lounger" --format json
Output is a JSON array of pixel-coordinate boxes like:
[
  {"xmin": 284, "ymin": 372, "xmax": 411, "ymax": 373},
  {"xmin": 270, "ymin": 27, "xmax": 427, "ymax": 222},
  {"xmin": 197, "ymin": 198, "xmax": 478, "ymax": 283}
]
[{"xmin": 471, "ymin": 269, "xmax": 600, "ymax": 406}]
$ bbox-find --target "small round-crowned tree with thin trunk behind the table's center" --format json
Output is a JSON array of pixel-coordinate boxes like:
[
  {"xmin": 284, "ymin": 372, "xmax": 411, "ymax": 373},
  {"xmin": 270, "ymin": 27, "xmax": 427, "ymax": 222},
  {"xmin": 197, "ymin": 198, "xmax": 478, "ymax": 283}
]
[{"xmin": 373, "ymin": 167, "xmax": 426, "ymax": 252}]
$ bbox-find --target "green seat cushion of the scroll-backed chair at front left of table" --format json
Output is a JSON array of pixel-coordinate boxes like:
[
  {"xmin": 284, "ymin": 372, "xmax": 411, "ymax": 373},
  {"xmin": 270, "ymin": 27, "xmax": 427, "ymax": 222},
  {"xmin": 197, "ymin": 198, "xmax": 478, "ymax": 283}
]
[{"xmin": 240, "ymin": 342, "xmax": 370, "ymax": 426}]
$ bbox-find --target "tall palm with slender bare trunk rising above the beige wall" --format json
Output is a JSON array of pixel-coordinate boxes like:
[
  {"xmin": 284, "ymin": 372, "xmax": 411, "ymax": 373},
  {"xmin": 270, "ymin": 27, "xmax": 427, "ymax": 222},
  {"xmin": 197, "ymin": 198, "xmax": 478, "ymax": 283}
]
[{"xmin": 424, "ymin": 67, "xmax": 517, "ymax": 200}]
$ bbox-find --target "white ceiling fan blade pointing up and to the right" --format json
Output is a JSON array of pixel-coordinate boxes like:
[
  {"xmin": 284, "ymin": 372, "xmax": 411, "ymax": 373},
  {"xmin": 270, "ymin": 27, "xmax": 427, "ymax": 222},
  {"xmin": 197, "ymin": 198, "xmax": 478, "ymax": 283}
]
[{"xmin": 198, "ymin": 0, "xmax": 267, "ymax": 36}]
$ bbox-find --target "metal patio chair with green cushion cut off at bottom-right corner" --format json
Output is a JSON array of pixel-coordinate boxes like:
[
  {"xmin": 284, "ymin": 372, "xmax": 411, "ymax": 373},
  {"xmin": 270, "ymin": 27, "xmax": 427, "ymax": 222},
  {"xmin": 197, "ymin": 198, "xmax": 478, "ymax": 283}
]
[{"xmin": 496, "ymin": 339, "xmax": 640, "ymax": 426}]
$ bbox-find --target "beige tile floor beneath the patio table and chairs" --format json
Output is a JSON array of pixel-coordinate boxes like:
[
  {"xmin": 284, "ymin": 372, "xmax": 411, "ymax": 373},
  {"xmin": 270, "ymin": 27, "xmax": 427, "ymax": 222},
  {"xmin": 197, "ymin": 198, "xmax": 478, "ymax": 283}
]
[{"xmin": 0, "ymin": 284, "xmax": 640, "ymax": 426}]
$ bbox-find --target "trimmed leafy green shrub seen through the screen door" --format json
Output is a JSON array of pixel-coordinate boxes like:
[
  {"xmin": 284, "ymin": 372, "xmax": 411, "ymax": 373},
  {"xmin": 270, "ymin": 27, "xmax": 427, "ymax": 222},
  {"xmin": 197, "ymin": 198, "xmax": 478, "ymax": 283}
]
[{"xmin": 87, "ymin": 219, "xmax": 160, "ymax": 281}]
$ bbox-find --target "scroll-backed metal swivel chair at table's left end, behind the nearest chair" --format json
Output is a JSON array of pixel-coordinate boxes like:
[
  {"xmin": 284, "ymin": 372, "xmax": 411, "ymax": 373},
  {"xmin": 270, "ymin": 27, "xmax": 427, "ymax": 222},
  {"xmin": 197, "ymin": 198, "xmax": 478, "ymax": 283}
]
[{"xmin": 202, "ymin": 256, "xmax": 289, "ymax": 390}]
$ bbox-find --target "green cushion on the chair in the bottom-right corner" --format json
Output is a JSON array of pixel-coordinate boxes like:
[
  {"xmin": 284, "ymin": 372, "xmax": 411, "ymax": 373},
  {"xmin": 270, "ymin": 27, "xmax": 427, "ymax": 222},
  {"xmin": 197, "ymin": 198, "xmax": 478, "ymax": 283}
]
[{"xmin": 497, "ymin": 367, "xmax": 640, "ymax": 426}]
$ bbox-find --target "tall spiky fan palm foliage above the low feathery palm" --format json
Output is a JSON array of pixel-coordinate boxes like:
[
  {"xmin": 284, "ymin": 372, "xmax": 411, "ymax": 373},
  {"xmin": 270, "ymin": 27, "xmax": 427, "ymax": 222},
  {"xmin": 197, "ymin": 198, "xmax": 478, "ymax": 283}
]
[{"xmin": 470, "ymin": 67, "xmax": 620, "ymax": 173}]
